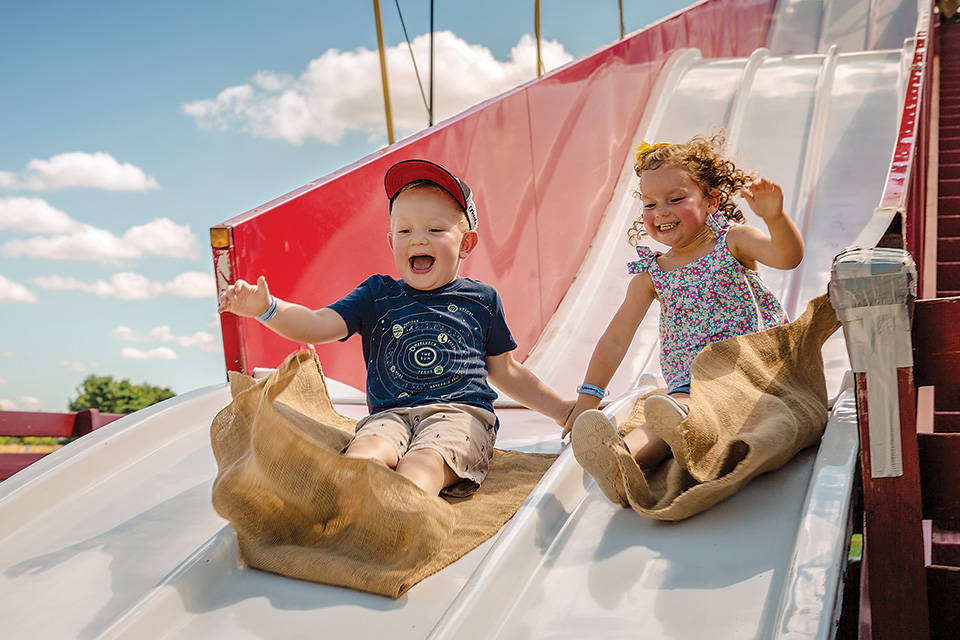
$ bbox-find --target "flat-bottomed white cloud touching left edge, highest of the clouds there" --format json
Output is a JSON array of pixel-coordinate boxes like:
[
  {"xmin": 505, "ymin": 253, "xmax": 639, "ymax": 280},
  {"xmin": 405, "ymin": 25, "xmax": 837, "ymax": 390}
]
[{"xmin": 0, "ymin": 151, "xmax": 160, "ymax": 191}]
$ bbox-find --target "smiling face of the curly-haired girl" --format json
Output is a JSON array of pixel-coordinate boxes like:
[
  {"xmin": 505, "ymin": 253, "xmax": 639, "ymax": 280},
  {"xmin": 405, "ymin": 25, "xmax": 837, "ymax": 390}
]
[{"xmin": 640, "ymin": 165, "xmax": 719, "ymax": 249}]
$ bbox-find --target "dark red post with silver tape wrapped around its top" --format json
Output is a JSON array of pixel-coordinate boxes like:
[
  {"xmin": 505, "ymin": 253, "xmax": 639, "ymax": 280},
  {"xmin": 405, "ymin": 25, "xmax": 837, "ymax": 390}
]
[{"xmin": 830, "ymin": 248, "xmax": 930, "ymax": 640}]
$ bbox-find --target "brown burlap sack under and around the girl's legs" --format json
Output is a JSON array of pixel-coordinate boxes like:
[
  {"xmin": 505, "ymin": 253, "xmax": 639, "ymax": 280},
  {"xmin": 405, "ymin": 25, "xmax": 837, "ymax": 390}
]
[{"xmin": 618, "ymin": 295, "xmax": 840, "ymax": 520}]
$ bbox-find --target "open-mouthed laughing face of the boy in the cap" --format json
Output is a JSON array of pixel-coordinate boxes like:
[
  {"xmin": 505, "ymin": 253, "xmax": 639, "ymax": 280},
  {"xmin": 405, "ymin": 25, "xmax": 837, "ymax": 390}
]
[{"xmin": 387, "ymin": 185, "xmax": 479, "ymax": 291}]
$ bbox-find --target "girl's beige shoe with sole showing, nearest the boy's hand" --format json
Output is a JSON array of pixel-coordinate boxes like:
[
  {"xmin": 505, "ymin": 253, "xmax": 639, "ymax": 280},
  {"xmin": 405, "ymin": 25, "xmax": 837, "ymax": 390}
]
[{"xmin": 570, "ymin": 409, "xmax": 630, "ymax": 507}]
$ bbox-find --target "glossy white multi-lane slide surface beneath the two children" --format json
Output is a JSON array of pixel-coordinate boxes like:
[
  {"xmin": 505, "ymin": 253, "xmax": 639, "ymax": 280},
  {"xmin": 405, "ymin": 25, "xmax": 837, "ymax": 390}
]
[{"xmin": 0, "ymin": 0, "xmax": 917, "ymax": 640}]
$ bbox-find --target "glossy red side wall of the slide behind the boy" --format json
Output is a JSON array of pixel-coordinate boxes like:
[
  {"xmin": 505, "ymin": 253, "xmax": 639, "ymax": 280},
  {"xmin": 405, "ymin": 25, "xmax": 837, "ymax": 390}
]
[{"xmin": 211, "ymin": 0, "xmax": 774, "ymax": 388}]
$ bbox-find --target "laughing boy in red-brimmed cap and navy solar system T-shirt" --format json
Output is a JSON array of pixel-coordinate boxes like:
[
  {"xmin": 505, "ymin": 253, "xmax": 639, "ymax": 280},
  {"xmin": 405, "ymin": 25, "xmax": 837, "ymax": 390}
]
[{"xmin": 219, "ymin": 160, "xmax": 574, "ymax": 496}]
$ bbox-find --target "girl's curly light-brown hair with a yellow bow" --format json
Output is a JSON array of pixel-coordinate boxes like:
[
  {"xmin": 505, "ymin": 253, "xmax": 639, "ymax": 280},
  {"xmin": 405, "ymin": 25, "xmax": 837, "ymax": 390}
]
[{"xmin": 627, "ymin": 133, "xmax": 756, "ymax": 246}]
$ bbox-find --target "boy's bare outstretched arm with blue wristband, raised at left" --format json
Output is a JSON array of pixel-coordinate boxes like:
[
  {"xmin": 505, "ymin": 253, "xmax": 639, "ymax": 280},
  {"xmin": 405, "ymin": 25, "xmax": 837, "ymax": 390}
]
[{"xmin": 217, "ymin": 276, "xmax": 348, "ymax": 344}]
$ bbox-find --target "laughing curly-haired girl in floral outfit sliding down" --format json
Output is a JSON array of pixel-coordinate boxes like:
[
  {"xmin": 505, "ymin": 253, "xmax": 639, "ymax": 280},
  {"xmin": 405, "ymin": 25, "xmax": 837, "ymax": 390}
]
[{"xmin": 563, "ymin": 134, "xmax": 803, "ymax": 506}]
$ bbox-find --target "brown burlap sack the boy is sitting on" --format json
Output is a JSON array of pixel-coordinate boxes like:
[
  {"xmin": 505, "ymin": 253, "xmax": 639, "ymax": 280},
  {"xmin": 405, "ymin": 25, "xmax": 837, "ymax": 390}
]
[{"xmin": 210, "ymin": 352, "xmax": 556, "ymax": 598}]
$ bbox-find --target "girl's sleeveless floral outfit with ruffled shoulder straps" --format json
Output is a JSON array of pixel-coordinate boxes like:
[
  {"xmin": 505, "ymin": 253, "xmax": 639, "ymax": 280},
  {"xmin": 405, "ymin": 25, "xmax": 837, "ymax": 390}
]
[{"xmin": 627, "ymin": 212, "xmax": 787, "ymax": 392}]
